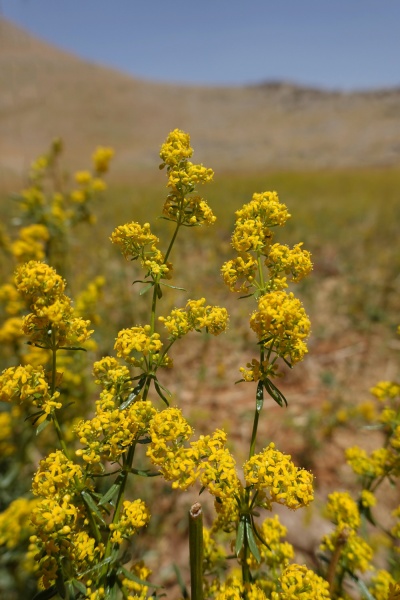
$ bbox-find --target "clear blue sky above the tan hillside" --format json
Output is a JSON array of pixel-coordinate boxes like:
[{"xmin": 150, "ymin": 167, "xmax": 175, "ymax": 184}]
[{"xmin": 0, "ymin": 0, "xmax": 400, "ymax": 90}]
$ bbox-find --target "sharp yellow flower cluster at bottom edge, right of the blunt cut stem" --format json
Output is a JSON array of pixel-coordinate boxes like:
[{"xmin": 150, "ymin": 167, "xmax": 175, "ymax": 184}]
[{"xmin": 271, "ymin": 564, "xmax": 330, "ymax": 600}]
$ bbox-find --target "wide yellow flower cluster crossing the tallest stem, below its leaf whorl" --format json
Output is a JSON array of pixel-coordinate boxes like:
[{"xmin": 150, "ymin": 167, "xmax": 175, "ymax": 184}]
[{"xmin": 74, "ymin": 390, "xmax": 156, "ymax": 465}]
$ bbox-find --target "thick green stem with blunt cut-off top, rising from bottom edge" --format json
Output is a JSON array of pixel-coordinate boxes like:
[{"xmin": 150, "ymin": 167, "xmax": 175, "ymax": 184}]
[{"xmin": 189, "ymin": 502, "xmax": 203, "ymax": 600}]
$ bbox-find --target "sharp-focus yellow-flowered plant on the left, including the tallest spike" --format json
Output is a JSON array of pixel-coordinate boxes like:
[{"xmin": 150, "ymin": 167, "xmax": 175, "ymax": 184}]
[{"xmin": 0, "ymin": 130, "xmax": 228, "ymax": 600}]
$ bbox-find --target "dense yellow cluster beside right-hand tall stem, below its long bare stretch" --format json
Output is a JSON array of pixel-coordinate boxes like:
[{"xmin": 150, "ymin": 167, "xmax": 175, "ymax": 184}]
[{"xmin": 243, "ymin": 443, "xmax": 314, "ymax": 509}]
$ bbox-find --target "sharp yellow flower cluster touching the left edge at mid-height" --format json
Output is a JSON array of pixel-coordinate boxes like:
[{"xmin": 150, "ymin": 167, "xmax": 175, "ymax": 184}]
[{"xmin": 0, "ymin": 365, "xmax": 61, "ymax": 414}]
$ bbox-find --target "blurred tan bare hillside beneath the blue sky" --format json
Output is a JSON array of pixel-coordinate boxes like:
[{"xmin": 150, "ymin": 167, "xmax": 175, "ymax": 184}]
[{"xmin": 0, "ymin": 20, "xmax": 400, "ymax": 182}]
